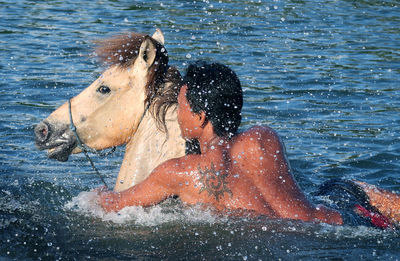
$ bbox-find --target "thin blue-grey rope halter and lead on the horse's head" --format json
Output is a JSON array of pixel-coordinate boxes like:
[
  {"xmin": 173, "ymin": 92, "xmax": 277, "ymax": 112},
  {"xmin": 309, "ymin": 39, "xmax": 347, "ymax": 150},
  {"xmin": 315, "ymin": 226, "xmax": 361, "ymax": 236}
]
[{"xmin": 68, "ymin": 99, "xmax": 150, "ymax": 189}]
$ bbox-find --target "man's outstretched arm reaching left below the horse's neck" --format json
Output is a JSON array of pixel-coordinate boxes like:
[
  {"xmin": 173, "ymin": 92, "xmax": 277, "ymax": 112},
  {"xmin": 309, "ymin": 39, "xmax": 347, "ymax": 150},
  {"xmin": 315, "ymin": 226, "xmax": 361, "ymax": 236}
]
[{"xmin": 100, "ymin": 159, "xmax": 180, "ymax": 212}]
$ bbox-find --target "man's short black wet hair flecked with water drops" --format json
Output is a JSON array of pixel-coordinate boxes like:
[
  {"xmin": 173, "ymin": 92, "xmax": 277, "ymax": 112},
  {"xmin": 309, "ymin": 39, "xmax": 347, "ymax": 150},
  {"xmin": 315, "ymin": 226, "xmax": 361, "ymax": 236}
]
[{"xmin": 183, "ymin": 61, "xmax": 243, "ymax": 138}]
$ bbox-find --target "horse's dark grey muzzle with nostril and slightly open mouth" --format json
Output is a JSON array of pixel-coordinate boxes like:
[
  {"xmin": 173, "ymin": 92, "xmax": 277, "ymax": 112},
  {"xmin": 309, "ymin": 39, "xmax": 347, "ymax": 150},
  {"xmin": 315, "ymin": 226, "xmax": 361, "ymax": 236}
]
[{"xmin": 35, "ymin": 121, "xmax": 77, "ymax": 161}]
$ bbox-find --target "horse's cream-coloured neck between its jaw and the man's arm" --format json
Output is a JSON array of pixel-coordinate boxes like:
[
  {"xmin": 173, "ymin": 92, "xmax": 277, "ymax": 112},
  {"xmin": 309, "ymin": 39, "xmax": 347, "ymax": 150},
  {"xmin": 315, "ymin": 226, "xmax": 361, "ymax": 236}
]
[{"xmin": 114, "ymin": 106, "xmax": 185, "ymax": 191}]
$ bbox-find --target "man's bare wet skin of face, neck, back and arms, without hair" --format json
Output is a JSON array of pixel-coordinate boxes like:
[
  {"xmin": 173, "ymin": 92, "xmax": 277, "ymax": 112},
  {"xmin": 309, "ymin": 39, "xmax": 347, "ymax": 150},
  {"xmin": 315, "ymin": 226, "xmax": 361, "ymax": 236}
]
[{"xmin": 100, "ymin": 65, "xmax": 342, "ymax": 224}]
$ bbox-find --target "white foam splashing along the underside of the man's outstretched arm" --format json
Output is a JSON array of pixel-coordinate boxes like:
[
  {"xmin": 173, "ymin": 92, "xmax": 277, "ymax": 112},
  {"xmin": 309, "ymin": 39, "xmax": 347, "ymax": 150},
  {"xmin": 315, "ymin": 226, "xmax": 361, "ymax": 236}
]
[{"xmin": 64, "ymin": 189, "xmax": 227, "ymax": 226}]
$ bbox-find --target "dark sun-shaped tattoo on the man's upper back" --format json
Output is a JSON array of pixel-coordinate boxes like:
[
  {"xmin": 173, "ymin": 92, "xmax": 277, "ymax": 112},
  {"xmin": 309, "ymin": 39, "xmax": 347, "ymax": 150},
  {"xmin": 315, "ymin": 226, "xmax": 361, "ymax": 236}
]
[{"xmin": 198, "ymin": 162, "xmax": 232, "ymax": 201}]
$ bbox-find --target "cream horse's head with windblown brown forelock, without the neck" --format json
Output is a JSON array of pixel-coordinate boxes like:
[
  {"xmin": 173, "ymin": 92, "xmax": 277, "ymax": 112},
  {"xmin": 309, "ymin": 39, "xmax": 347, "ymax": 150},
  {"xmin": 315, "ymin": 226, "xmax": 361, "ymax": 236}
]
[{"xmin": 35, "ymin": 30, "xmax": 179, "ymax": 161}]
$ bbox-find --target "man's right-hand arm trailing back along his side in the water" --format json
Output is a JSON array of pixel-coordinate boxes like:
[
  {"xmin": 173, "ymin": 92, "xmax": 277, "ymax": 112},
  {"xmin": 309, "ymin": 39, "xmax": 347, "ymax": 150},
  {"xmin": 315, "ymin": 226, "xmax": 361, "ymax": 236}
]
[{"xmin": 238, "ymin": 127, "xmax": 342, "ymax": 224}]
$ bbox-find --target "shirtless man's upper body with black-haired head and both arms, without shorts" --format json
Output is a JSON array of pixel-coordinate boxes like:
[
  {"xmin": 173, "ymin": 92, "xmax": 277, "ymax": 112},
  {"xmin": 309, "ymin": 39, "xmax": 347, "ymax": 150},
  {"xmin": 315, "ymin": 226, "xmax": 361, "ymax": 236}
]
[{"xmin": 100, "ymin": 60, "xmax": 343, "ymax": 224}]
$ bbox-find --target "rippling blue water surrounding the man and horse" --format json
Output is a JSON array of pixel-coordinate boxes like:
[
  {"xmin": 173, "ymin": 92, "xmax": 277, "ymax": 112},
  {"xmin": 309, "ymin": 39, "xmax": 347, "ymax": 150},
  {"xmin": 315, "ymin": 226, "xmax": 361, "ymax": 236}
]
[{"xmin": 0, "ymin": 0, "xmax": 400, "ymax": 260}]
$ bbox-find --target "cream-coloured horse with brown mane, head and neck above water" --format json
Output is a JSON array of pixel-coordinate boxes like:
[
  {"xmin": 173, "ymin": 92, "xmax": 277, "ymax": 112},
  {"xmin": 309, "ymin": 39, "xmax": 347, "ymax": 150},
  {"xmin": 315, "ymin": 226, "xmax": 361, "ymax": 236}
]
[{"xmin": 34, "ymin": 29, "xmax": 195, "ymax": 192}]
